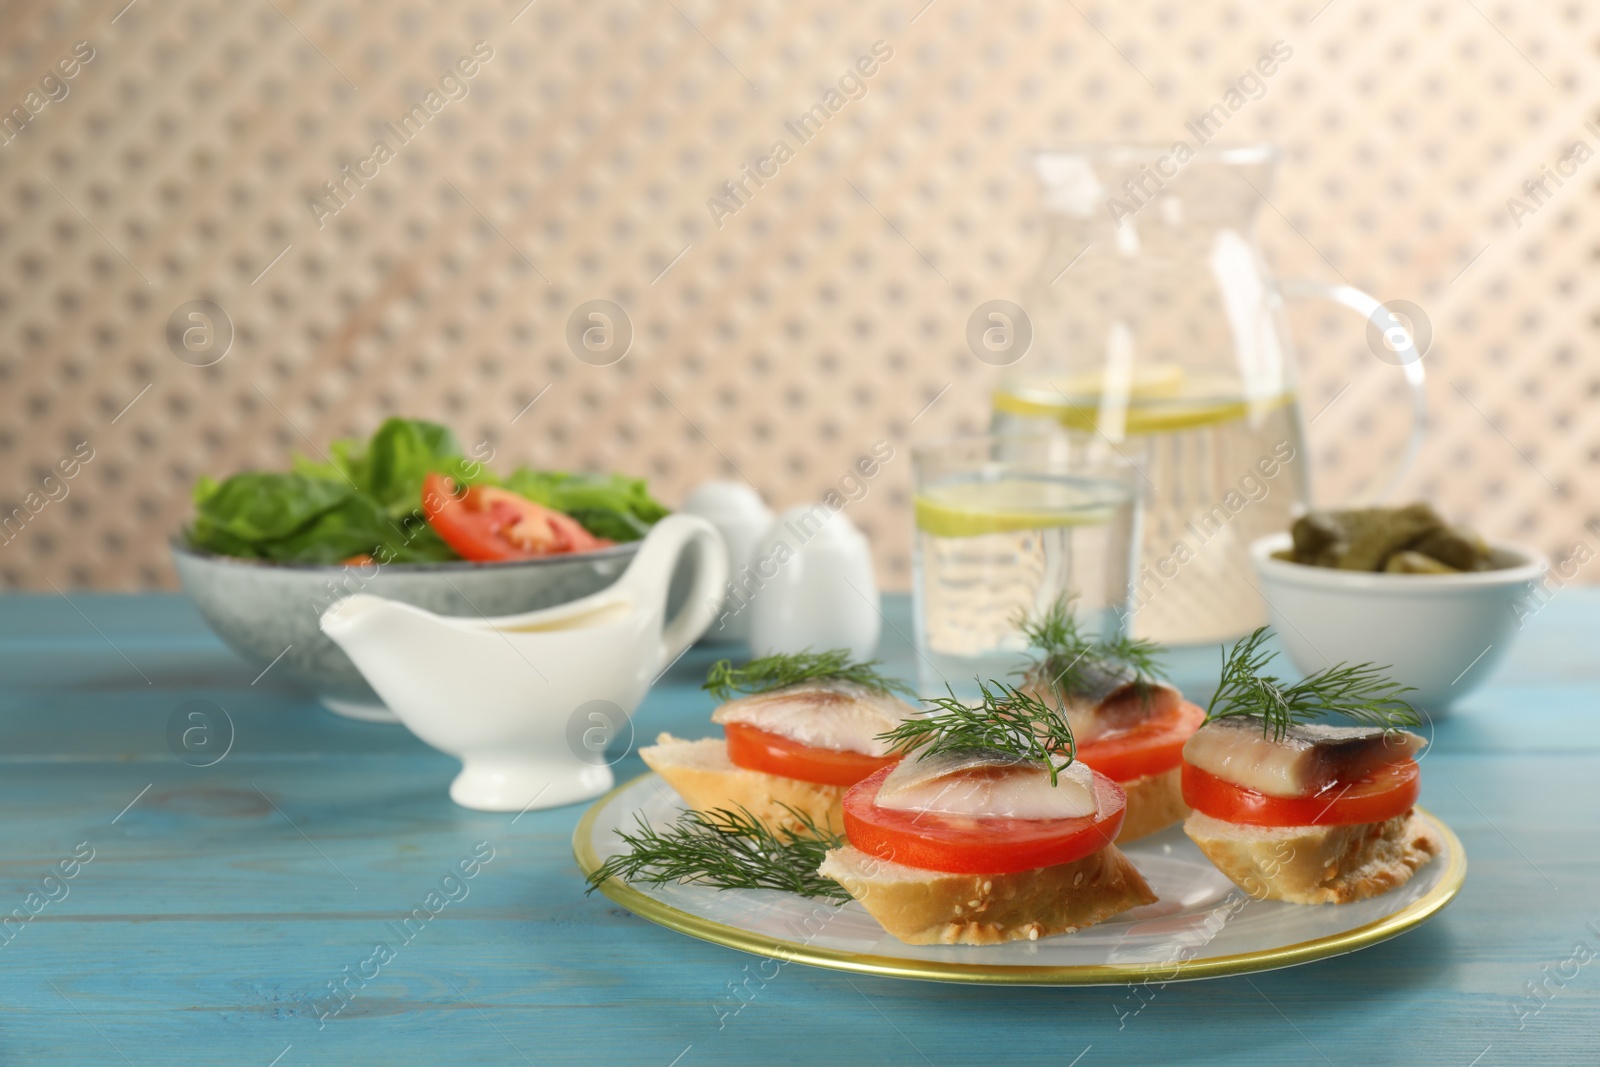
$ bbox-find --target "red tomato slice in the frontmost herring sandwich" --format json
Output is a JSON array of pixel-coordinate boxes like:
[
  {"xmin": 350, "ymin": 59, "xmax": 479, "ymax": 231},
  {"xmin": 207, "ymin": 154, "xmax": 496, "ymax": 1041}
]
[{"xmin": 845, "ymin": 768, "xmax": 1128, "ymax": 875}]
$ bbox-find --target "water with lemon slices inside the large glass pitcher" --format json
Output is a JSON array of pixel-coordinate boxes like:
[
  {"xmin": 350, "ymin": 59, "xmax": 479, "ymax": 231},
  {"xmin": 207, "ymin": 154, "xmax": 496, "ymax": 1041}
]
[{"xmin": 994, "ymin": 365, "xmax": 1307, "ymax": 645}]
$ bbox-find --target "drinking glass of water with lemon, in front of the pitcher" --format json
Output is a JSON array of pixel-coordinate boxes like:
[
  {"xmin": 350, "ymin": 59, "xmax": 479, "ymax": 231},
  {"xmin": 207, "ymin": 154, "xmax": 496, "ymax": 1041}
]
[{"xmin": 912, "ymin": 432, "xmax": 1139, "ymax": 699}]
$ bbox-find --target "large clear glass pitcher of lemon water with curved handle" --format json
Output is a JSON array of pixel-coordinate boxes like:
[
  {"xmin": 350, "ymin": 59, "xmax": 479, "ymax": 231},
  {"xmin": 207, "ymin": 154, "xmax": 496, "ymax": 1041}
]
[{"xmin": 992, "ymin": 144, "xmax": 1426, "ymax": 645}]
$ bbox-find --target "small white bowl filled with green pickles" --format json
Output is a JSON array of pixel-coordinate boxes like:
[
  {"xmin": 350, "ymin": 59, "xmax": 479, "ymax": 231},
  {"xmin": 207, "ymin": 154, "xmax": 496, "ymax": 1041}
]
[{"xmin": 1250, "ymin": 504, "xmax": 1549, "ymax": 718}]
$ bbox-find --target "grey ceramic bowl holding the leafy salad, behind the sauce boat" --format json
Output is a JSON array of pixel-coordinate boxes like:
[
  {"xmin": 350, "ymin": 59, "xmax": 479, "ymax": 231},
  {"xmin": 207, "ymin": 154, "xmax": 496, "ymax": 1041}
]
[{"xmin": 171, "ymin": 537, "xmax": 643, "ymax": 723}]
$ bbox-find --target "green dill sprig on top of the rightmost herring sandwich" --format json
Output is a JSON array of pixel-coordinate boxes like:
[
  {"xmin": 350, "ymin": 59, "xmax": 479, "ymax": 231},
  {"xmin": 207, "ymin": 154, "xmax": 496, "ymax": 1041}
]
[{"xmin": 1205, "ymin": 627, "xmax": 1422, "ymax": 741}]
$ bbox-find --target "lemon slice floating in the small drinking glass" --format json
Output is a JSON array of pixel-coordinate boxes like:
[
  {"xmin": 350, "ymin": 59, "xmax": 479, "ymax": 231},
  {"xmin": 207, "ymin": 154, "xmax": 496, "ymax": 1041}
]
[{"xmin": 915, "ymin": 475, "xmax": 1128, "ymax": 537}]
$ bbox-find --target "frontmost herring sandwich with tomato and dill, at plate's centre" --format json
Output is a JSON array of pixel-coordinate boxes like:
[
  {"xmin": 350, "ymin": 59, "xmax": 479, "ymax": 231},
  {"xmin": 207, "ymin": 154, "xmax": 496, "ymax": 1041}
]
[{"xmin": 818, "ymin": 683, "xmax": 1155, "ymax": 945}]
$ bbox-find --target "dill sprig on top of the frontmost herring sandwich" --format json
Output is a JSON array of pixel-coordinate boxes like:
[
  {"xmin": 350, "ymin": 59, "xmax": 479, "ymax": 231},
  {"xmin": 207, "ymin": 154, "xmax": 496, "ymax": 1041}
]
[{"xmin": 878, "ymin": 678, "xmax": 1078, "ymax": 785}]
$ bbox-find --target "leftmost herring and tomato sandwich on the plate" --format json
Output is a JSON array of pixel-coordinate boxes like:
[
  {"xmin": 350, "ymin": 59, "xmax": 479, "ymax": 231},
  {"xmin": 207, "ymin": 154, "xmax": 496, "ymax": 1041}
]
[{"xmin": 638, "ymin": 649, "xmax": 917, "ymax": 832}]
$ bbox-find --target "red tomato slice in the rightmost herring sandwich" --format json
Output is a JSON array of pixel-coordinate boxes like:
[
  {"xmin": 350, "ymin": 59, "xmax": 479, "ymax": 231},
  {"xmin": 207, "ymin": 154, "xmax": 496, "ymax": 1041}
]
[{"xmin": 1184, "ymin": 760, "xmax": 1422, "ymax": 825}]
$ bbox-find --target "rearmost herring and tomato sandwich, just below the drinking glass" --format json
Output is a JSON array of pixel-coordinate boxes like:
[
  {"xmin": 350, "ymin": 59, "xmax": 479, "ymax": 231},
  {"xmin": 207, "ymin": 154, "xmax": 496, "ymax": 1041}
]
[{"xmin": 1022, "ymin": 600, "xmax": 1205, "ymax": 843}]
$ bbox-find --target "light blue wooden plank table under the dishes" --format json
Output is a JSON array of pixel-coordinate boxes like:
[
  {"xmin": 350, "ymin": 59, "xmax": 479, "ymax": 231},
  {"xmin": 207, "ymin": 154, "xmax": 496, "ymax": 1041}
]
[{"xmin": 0, "ymin": 590, "xmax": 1600, "ymax": 1067}]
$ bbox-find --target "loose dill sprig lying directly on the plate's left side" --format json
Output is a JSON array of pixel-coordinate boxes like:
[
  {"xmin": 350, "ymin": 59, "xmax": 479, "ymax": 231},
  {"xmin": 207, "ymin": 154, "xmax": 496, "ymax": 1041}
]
[{"xmin": 584, "ymin": 805, "xmax": 850, "ymax": 904}]
